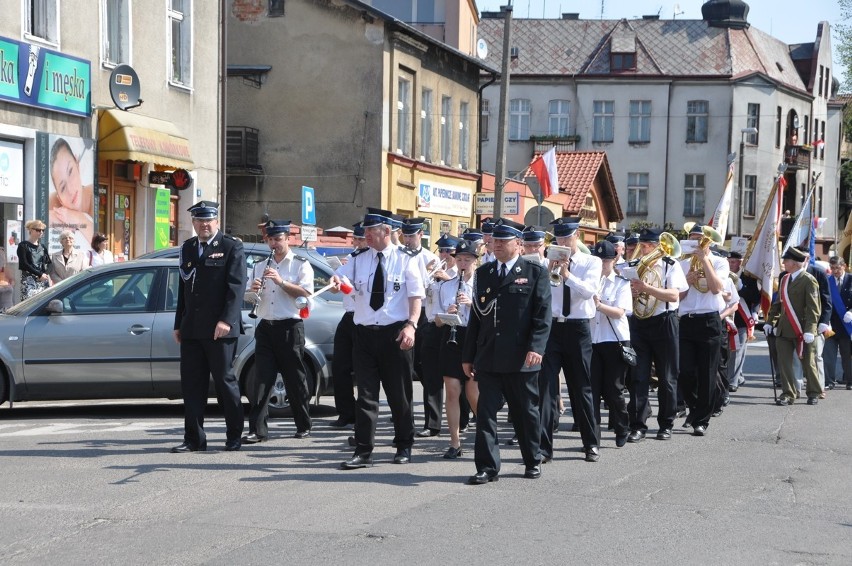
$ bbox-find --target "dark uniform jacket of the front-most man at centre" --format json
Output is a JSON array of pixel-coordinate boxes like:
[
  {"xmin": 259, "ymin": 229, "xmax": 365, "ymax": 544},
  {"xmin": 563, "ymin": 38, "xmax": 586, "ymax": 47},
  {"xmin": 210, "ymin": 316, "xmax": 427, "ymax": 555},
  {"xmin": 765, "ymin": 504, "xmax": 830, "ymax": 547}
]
[{"xmin": 462, "ymin": 257, "xmax": 553, "ymax": 373}]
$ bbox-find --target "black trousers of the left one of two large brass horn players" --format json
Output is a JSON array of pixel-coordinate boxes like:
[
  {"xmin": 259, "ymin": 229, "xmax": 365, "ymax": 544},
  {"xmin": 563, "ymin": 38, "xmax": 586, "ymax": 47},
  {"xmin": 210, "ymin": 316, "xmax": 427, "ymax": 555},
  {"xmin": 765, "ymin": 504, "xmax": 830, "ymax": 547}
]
[{"xmin": 627, "ymin": 311, "xmax": 680, "ymax": 430}]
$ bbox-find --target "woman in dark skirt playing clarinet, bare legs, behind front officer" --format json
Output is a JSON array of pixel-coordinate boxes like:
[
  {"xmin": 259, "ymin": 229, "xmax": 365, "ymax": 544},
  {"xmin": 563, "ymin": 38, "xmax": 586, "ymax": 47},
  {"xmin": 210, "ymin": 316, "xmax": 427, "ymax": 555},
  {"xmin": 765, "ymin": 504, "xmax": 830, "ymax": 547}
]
[{"xmin": 435, "ymin": 241, "xmax": 479, "ymax": 460}]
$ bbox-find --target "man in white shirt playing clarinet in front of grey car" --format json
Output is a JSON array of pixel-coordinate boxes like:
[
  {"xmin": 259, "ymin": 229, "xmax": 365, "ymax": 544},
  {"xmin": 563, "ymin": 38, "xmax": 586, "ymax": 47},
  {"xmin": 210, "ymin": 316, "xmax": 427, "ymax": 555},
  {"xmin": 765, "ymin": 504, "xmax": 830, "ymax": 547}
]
[{"xmin": 243, "ymin": 220, "xmax": 314, "ymax": 444}]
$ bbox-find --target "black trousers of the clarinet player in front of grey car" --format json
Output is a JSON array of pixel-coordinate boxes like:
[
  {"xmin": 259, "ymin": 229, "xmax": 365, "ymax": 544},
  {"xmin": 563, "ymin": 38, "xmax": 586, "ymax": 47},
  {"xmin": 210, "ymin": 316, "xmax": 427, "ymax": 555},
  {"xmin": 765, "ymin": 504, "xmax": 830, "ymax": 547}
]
[{"xmin": 248, "ymin": 319, "xmax": 311, "ymax": 437}]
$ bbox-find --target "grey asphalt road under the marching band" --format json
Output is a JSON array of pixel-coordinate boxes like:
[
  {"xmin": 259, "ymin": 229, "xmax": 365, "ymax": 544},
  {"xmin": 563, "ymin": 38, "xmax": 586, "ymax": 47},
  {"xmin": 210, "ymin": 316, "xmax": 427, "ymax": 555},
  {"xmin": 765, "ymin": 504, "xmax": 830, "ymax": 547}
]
[{"xmin": 0, "ymin": 342, "xmax": 852, "ymax": 566}]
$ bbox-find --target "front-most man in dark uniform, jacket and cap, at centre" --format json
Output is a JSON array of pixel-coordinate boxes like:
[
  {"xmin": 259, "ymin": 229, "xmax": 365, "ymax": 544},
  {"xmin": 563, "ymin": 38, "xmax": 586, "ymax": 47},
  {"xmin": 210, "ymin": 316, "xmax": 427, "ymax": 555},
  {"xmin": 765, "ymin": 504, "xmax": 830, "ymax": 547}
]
[{"xmin": 462, "ymin": 218, "xmax": 551, "ymax": 485}]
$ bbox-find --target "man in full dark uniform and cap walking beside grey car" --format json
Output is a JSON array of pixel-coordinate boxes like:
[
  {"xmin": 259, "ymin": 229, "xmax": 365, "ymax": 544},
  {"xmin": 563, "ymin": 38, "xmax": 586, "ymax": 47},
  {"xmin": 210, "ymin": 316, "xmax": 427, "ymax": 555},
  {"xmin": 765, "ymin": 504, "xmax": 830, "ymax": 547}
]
[{"xmin": 172, "ymin": 201, "xmax": 246, "ymax": 452}]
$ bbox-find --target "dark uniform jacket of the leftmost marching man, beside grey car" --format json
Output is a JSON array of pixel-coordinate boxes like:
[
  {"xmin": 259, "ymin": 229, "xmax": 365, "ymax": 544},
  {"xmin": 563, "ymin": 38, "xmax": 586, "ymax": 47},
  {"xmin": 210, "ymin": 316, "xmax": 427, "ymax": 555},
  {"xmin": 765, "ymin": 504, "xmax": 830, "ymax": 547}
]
[{"xmin": 175, "ymin": 230, "xmax": 246, "ymax": 339}]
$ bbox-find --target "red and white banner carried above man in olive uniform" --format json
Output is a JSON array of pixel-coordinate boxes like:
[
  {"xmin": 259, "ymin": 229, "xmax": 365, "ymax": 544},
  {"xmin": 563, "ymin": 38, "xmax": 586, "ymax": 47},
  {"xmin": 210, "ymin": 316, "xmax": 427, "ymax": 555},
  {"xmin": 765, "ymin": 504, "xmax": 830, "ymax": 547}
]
[{"xmin": 743, "ymin": 172, "xmax": 787, "ymax": 315}]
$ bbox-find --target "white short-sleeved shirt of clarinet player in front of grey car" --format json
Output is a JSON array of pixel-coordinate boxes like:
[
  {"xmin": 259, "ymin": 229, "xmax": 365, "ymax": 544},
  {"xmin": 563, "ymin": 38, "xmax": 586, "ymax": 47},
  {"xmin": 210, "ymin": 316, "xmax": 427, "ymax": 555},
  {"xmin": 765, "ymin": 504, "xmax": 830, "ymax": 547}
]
[{"xmin": 246, "ymin": 250, "xmax": 314, "ymax": 320}]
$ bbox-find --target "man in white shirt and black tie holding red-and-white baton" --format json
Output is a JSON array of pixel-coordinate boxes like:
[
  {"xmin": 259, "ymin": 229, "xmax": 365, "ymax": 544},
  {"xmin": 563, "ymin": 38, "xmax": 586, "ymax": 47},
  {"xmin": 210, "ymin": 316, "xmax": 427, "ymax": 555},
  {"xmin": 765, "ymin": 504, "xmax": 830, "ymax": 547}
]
[{"xmin": 332, "ymin": 208, "xmax": 424, "ymax": 470}]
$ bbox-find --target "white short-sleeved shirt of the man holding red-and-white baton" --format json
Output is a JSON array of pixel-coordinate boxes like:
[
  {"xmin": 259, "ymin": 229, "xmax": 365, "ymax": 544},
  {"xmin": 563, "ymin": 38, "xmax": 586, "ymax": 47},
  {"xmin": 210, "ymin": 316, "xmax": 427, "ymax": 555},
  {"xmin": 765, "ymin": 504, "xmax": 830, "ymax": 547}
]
[{"xmin": 335, "ymin": 245, "xmax": 425, "ymax": 326}]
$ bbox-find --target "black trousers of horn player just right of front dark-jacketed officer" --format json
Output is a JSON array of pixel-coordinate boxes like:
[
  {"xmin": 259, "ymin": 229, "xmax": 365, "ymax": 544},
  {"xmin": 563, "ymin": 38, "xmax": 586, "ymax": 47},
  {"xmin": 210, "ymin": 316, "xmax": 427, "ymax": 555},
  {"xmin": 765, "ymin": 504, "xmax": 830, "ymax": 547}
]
[{"xmin": 544, "ymin": 319, "xmax": 601, "ymax": 457}]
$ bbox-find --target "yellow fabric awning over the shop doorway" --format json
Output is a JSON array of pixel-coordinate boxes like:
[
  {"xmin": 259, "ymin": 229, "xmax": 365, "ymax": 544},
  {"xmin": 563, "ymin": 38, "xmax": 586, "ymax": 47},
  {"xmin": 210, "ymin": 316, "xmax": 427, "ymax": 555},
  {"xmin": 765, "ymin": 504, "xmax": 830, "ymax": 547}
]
[{"xmin": 98, "ymin": 110, "xmax": 195, "ymax": 169}]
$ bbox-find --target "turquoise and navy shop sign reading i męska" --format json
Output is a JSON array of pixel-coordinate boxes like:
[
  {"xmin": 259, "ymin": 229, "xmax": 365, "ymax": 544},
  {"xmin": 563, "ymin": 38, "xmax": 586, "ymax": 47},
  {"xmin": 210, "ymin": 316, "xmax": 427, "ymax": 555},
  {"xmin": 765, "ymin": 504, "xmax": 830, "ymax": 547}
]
[{"xmin": 0, "ymin": 37, "xmax": 92, "ymax": 116}]
